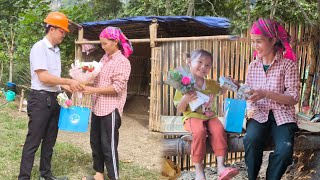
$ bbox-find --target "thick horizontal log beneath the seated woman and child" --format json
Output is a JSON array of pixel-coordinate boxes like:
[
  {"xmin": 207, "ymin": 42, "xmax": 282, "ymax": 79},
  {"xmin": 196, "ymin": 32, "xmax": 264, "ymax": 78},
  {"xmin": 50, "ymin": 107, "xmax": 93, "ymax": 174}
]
[{"xmin": 162, "ymin": 133, "xmax": 320, "ymax": 156}]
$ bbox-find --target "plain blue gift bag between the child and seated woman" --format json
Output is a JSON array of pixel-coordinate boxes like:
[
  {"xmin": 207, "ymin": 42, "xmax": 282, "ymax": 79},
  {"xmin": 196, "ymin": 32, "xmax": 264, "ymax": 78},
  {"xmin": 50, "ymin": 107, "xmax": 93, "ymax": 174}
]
[{"xmin": 224, "ymin": 98, "xmax": 246, "ymax": 133}]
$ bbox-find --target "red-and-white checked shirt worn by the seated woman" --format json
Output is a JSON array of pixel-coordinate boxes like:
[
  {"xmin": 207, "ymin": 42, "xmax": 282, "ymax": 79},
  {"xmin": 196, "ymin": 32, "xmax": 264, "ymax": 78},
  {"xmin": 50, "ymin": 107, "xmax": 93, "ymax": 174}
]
[{"xmin": 246, "ymin": 54, "xmax": 300, "ymax": 126}]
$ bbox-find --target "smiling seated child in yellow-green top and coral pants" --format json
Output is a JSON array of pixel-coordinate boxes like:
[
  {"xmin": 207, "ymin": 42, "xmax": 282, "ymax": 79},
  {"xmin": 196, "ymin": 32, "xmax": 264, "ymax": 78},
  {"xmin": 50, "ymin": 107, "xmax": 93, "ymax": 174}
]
[{"xmin": 174, "ymin": 49, "xmax": 239, "ymax": 180}]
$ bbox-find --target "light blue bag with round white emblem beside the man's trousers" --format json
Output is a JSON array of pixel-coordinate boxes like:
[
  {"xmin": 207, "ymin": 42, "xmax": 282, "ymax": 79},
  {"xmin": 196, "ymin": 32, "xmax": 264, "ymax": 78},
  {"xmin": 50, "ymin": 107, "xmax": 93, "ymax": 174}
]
[{"xmin": 58, "ymin": 106, "xmax": 91, "ymax": 132}]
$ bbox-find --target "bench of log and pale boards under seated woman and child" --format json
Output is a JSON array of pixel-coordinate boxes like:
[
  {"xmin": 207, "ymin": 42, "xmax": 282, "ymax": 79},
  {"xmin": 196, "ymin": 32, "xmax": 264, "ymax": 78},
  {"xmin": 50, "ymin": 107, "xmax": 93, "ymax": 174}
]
[{"xmin": 161, "ymin": 114, "xmax": 320, "ymax": 156}]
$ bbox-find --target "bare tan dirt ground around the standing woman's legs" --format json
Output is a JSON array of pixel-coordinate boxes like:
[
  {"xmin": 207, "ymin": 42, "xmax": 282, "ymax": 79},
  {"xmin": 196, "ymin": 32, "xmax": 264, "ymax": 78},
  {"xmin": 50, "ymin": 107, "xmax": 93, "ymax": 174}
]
[{"xmin": 57, "ymin": 96, "xmax": 161, "ymax": 173}]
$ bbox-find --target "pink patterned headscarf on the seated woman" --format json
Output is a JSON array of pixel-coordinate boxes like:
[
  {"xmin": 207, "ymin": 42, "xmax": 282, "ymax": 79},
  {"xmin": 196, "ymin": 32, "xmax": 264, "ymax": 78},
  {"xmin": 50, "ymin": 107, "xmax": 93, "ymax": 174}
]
[{"xmin": 250, "ymin": 18, "xmax": 296, "ymax": 61}]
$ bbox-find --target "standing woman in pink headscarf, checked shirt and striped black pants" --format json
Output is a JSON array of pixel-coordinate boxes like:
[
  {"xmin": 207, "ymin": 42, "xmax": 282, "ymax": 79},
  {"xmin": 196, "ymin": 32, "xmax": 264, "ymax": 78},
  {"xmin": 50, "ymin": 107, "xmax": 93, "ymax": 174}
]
[{"xmin": 83, "ymin": 26, "xmax": 133, "ymax": 180}]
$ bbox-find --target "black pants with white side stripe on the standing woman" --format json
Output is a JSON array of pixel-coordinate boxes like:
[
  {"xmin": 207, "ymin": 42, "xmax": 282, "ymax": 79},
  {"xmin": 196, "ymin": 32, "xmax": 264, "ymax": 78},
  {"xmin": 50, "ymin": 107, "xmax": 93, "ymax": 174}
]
[{"xmin": 90, "ymin": 109, "xmax": 121, "ymax": 180}]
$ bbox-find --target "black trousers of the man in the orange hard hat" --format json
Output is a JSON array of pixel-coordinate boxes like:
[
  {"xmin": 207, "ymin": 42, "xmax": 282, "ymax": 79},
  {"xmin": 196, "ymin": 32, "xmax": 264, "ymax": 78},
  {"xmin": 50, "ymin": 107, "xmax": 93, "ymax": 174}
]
[{"xmin": 18, "ymin": 90, "xmax": 60, "ymax": 180}]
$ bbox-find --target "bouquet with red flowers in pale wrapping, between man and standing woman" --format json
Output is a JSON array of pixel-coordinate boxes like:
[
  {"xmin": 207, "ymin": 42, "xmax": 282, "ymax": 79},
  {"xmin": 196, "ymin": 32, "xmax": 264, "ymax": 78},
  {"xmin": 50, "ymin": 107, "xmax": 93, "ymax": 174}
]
[{"xmin": 69, "ymin": 60, "xmax": 102, "ymax": 84}]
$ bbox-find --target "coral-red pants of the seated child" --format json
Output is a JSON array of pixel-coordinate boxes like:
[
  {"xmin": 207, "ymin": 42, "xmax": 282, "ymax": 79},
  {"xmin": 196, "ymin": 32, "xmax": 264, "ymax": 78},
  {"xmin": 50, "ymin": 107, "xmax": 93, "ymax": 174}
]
[{"xmin": 184, "ymin": 118, "xmax": 228, "ymax": 163}]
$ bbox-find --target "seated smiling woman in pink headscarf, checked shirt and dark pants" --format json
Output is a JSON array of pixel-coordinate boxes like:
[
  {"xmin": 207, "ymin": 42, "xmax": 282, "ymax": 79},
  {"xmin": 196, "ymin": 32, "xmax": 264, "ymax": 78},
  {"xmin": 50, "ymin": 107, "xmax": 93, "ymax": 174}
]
[{"xmin": 243, "ymin": 18, "xmax": 300, "ymax": 180}]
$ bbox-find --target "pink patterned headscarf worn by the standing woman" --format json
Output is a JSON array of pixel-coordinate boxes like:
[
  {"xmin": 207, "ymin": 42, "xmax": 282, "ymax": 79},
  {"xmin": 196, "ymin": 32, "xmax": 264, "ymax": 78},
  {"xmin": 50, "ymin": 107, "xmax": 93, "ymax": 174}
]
[{"xmin": 99, "ymin": 26, "xmax": 133, "ymax": 58}]
